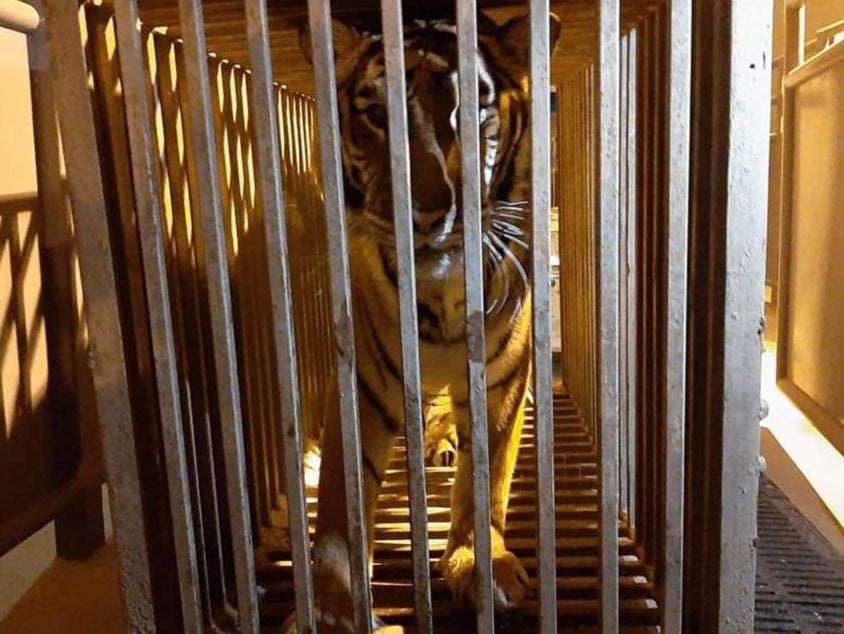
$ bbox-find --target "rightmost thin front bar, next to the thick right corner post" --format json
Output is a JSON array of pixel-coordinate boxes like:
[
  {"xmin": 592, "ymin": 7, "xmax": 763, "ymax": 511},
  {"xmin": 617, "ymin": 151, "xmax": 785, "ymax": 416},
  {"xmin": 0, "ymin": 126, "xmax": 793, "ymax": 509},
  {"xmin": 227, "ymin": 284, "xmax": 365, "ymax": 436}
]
[{"xmin": 661, "ymin": 0, "xmax": 692, "ymax": 634}]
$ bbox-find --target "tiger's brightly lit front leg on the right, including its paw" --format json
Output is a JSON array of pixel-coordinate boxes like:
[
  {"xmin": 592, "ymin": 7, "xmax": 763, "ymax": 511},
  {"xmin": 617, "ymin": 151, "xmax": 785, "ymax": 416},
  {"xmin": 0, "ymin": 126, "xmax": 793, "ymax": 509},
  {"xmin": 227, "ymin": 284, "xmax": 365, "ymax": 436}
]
[{"xmin": 440, "ymin": 355, "xmax": 530, "ymax": 611}]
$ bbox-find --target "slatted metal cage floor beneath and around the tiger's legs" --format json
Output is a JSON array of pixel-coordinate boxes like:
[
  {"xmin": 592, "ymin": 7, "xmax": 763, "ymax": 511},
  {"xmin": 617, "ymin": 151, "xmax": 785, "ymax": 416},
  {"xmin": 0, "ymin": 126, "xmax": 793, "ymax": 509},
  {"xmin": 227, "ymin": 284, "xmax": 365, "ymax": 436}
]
[{"xmin": 258, "ymin": 394, "xmax": 658, "ymax": 634}]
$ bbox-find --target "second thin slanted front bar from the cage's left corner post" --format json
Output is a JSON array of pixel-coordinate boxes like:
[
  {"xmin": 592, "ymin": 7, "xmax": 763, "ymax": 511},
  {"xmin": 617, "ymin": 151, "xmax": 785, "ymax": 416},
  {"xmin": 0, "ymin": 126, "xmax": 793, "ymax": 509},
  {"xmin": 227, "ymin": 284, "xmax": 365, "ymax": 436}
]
[{"xmin": 179, "ymin": 0, "xmax": 258, "ymax": 634}]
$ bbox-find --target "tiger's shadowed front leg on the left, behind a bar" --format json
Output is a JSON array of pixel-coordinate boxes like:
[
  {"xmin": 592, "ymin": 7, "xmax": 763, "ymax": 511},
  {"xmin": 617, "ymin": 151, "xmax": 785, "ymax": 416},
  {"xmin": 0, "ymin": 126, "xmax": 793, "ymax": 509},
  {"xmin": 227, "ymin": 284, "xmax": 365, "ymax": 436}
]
[{"xmin": 296, "ymin": 382, "xmax": 400, "ymax": 634}]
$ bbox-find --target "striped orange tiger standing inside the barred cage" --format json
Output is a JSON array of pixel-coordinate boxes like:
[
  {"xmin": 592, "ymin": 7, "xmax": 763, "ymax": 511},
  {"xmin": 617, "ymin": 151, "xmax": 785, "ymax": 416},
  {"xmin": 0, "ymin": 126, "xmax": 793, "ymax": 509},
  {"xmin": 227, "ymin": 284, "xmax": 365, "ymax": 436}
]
[{"xmin": 287, "ymin": 13, "xmax": 560, "ymax": 634}]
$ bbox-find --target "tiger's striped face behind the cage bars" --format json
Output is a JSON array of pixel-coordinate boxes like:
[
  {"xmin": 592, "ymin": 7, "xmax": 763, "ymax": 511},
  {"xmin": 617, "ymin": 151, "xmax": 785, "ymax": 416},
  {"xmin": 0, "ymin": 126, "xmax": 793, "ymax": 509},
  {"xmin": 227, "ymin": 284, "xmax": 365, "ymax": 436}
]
[{"xmin": 303, "ymin": 16, "xmax": 559, "ymax": 260}]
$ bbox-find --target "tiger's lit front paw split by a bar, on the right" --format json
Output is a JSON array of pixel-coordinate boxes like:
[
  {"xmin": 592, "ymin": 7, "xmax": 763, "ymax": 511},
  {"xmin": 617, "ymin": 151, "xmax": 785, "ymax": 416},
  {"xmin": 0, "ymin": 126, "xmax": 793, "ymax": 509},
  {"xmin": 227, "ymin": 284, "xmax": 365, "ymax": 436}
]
[{"xmin": 439, "ymin": 546, "xmax": 530, "ymax": 612}]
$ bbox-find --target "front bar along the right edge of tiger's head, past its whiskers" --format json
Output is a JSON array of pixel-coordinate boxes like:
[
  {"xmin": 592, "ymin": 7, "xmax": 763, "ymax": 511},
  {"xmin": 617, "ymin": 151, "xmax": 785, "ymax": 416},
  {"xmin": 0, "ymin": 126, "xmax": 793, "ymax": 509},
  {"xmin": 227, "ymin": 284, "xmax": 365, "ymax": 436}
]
[{"xmin": 528, "ymin": 0, "xmax": 557, "ymax": 634}]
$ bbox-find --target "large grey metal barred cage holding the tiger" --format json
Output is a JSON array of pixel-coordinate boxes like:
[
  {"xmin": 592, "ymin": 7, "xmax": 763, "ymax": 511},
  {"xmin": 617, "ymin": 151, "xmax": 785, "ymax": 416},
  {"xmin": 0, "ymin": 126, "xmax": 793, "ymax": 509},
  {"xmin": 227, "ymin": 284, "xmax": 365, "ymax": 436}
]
[{"xmin": 16, "ymin": 0, "xmax": 771, "ymax": 634}]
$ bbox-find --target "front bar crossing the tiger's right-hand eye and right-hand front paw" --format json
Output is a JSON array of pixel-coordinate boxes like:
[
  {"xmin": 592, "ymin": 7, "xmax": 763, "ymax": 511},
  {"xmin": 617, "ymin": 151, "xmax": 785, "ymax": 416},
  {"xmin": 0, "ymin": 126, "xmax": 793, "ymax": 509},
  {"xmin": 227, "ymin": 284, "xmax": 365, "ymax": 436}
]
[{"xmin": 457, "ymin": 0, "xmax": 494, "ymax": 632}]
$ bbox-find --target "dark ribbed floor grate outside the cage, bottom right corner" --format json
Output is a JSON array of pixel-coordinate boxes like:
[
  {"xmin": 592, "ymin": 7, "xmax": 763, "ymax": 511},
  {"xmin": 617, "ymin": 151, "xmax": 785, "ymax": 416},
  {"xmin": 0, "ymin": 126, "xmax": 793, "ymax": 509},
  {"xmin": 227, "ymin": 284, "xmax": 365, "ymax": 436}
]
[{"xmin": 755, "ymin": 477, "xmax": 844, "ymax": 634}]
